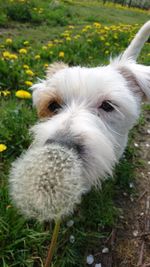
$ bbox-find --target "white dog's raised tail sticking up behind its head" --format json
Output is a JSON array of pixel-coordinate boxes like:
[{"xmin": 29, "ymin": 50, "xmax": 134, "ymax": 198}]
[{"xmin": 121, "ymin": 20, "xmax": 150, "ymax": 60}]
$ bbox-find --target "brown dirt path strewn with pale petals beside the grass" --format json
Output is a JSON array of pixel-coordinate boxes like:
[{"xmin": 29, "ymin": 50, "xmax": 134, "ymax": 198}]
[{"xmin": 93, "ymin": 107, "xmax": 150, "ymax": 267}]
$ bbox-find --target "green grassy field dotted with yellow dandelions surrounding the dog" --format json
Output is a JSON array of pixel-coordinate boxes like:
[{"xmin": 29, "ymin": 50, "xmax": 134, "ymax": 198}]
[{"xmin": 0, "ymin": 0, "xmax": 150, "ymax": 267}]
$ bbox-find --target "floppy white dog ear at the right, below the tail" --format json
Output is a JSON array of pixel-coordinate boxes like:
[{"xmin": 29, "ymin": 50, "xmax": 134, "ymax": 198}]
[{"xmin": 118, "ymin": 62, "xmax": 150, "ymax": 99}]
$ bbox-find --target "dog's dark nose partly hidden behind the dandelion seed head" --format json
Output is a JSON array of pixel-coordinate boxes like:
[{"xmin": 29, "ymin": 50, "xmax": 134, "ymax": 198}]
[{"xmin": 46, "ymin": 139, "xmax": 84, "ymax": 155}]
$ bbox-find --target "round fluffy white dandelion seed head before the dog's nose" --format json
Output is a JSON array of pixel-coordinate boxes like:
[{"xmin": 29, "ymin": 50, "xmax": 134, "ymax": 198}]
[{"xmin": 9, "ymin": 144, "xmax": 87, "ymax": 221}]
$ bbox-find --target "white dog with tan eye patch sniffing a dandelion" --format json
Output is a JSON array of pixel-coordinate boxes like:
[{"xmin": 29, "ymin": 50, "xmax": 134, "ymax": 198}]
[{"xmin": 32, "ymin": 21, "xmax": 150, "ymax": 191}]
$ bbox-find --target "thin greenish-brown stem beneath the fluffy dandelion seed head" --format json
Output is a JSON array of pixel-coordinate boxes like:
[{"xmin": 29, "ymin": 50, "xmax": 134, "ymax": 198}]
[{"xmin": 44, "ymin": 219, "xmax": 61, "ymax": 267}]
